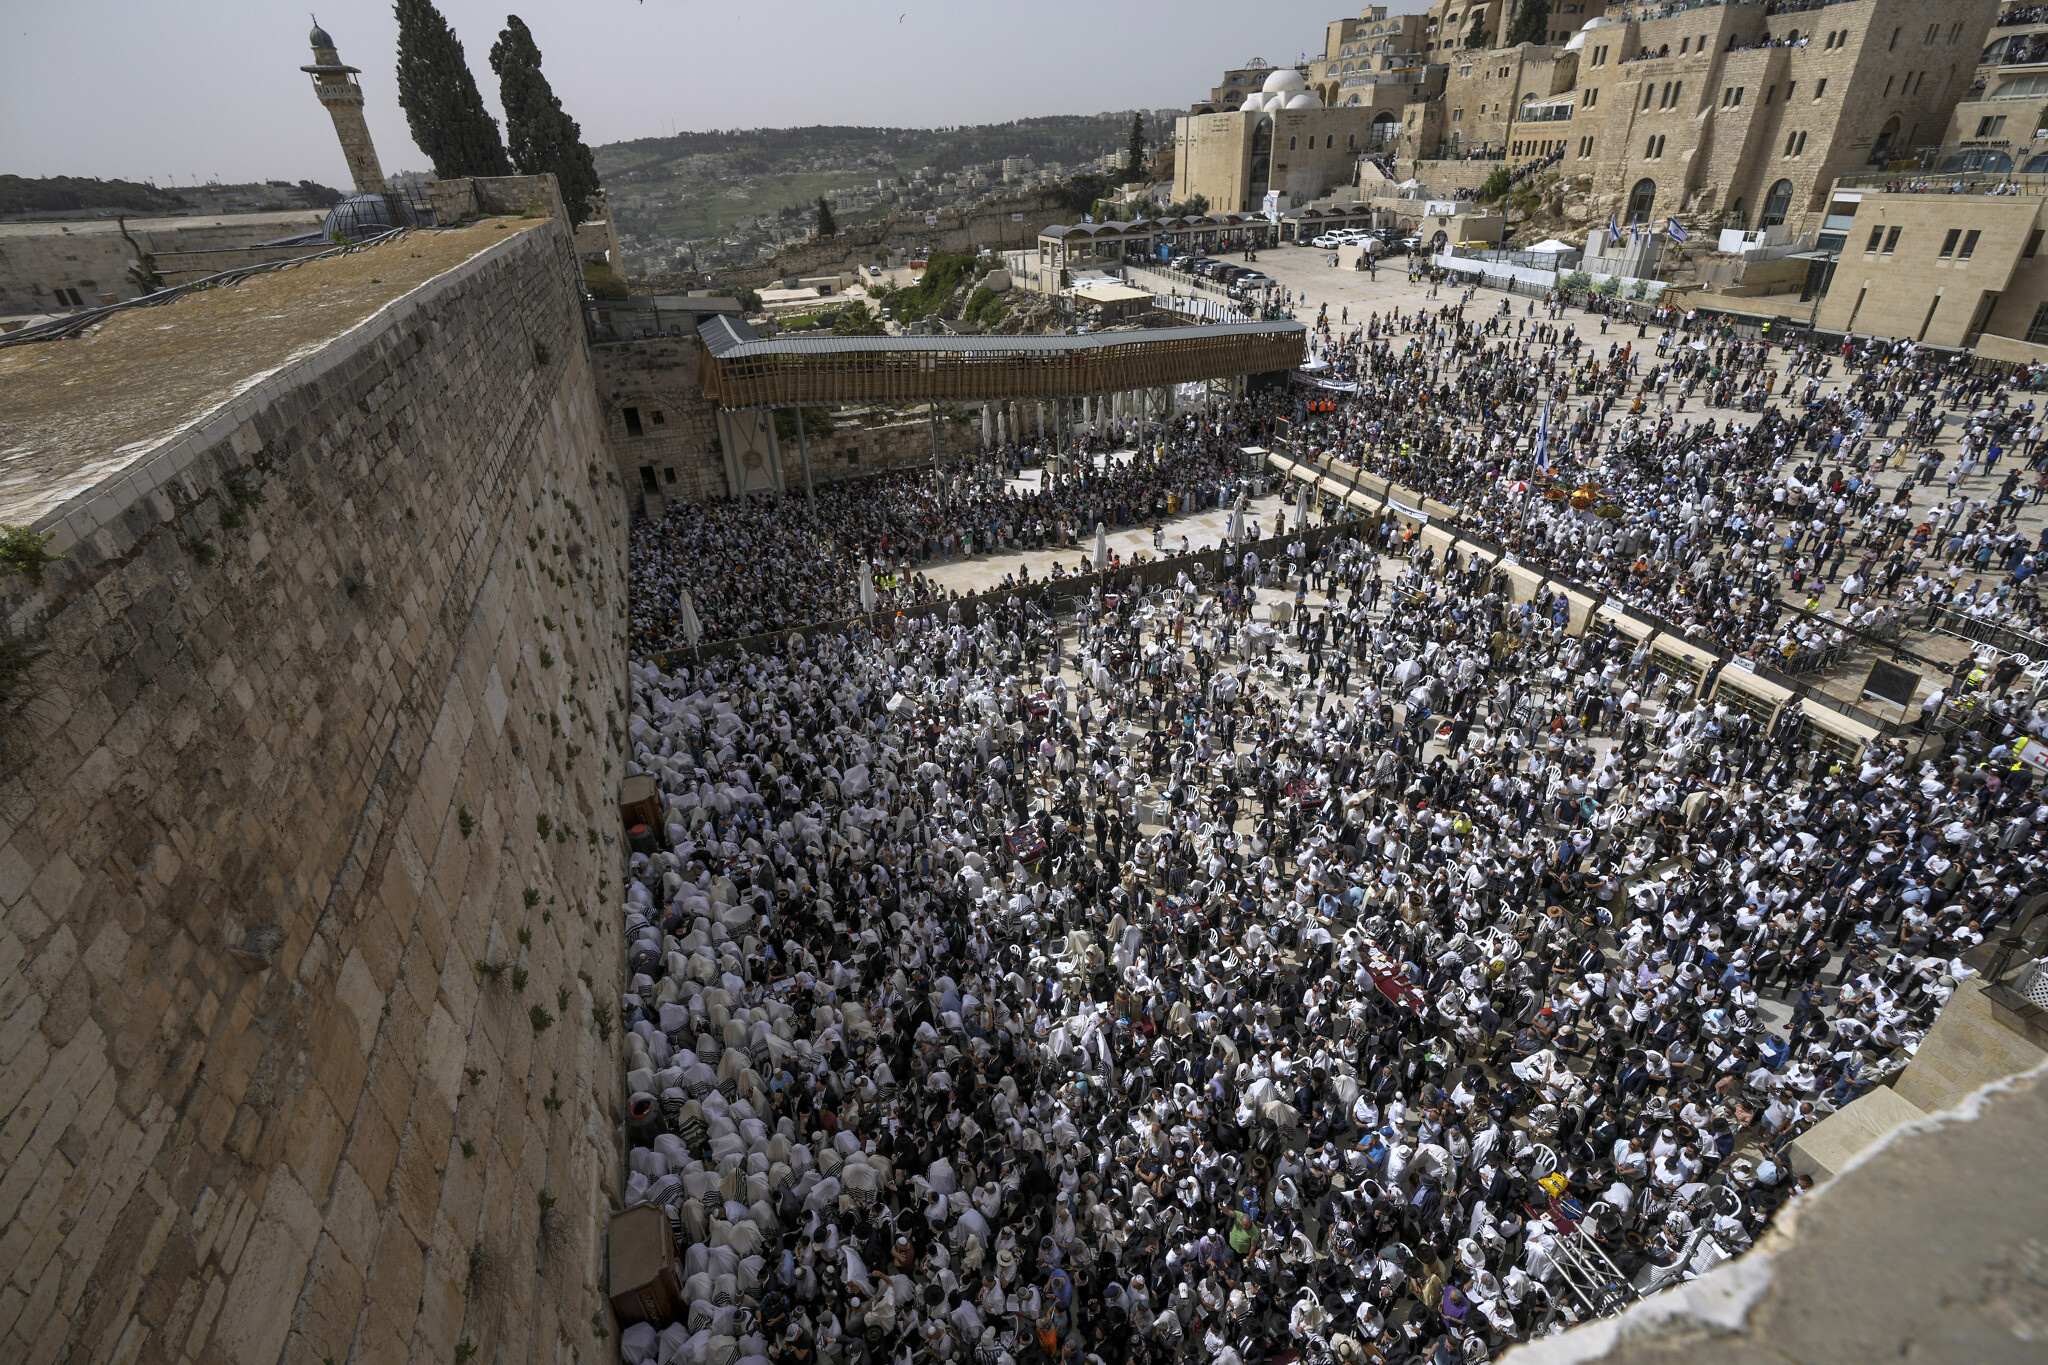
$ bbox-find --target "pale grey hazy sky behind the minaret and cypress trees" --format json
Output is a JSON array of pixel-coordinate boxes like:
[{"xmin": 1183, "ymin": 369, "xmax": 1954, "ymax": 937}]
[{"xmin": 0, "ymin": 0, "xmax": 1423, "ymax": 188}]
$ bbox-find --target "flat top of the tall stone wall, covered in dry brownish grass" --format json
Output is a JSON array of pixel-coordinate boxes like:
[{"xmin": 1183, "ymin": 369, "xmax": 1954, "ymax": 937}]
[{"xmin": 0, "ymin": 219, "xmax": 547, "ymax": 526}]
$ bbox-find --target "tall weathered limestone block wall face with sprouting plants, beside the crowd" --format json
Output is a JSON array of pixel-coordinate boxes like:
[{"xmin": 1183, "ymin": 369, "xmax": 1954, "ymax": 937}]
[{"xmin": 0, "ymin": 221, "xmax": 625, "ymax": 1365}]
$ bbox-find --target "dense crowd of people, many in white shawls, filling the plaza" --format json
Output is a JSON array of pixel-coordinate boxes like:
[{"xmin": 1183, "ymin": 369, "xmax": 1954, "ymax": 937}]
[{"xmin": 621, "ymin": 290, "xmax": 2048, "ymax": 1365}]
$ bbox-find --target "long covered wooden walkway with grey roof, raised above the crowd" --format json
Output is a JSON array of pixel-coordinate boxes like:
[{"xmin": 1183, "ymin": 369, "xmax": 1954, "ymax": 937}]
[{"xmin": 696, "ymin": 317, "xmax": 1309, "ymax": 407}]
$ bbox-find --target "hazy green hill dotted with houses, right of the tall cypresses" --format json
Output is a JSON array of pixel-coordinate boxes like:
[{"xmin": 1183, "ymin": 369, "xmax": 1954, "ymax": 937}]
[{"xmin": 596, "ymin": 108, "xmax": 1159, "ymax": 239}]
